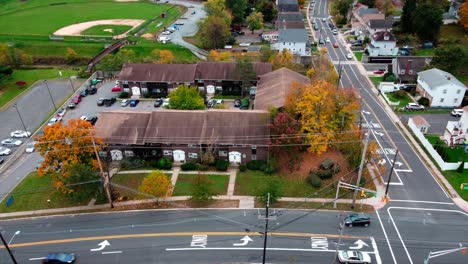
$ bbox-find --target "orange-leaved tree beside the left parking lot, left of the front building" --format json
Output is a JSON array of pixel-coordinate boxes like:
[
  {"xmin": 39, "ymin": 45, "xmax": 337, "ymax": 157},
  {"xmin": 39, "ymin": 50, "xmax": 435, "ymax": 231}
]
[{"xmin": 35, "ymin": 119, "xmax": 101, "ymax": 193}]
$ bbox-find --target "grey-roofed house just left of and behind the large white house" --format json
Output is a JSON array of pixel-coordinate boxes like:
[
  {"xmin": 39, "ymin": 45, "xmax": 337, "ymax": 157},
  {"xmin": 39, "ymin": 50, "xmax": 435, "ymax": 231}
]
[{"xmin": 392, "ymin": 56, "xmax": 431, "ymax": 83}]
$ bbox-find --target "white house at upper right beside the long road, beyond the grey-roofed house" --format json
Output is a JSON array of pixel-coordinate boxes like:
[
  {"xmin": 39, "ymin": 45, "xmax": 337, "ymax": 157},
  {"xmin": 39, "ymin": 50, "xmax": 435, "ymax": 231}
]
[{"xmin": 367, "ymin": 31, "xmax": 398, "ymax": 57}]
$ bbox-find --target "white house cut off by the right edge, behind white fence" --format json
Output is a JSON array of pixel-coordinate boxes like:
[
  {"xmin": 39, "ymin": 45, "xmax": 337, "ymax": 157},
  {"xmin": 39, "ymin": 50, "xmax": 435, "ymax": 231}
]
[{"xmin": 444, "ymin": 106, "xmax": 468, "ymax": 146}]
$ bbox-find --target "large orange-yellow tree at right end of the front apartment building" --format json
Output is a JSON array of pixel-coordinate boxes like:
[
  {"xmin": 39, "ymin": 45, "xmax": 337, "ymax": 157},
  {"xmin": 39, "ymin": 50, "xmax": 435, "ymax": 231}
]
[{"xmin": 286, "ymin": 80, "xmax": 359, "ymax": 154}]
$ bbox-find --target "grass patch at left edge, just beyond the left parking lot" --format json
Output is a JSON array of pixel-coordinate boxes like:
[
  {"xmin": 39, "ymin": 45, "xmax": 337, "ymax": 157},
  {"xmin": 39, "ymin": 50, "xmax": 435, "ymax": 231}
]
[{"xmin": 0, "ymin": 69, "xmax": 76, "ymax": 107}]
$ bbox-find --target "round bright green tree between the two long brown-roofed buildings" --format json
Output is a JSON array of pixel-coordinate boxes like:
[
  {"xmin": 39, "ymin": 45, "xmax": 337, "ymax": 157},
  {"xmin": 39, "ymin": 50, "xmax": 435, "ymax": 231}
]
[{"xmin": 169, "ymin": 85, "xmax": 205, "ymax": 110}]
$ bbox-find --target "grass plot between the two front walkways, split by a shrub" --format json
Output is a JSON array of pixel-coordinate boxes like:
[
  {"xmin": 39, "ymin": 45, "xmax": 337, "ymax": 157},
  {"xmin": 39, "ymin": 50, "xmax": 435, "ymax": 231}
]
[{"xmin": 172, "ymin": 174, "xmax": 229, "ymax": 196}]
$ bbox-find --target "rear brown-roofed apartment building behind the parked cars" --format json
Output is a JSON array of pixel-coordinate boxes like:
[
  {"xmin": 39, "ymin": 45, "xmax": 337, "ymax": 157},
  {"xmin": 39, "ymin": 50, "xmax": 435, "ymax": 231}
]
[{"xmin": 118, "ymin": 62, "xmax": 271, "ymax": 97}]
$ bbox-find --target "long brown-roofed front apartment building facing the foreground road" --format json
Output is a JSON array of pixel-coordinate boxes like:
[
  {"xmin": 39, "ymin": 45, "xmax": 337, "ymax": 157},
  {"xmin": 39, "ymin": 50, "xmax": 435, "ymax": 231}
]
[{"xmin": 95, "ymin": 110, "xmax": 270, "ymax": 164}]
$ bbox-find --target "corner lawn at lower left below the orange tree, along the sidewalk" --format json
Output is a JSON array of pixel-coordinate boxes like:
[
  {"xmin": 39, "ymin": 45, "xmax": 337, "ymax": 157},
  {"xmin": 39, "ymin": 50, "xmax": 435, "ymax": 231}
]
[{"xmin": 0, "ymin": 172, "xmax": 98, "ymax": 213}]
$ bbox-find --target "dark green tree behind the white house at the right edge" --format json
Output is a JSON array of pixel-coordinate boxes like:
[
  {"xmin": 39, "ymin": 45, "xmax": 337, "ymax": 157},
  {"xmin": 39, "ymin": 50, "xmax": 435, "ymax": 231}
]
[{"xmin": 431, "ymin": 46, "xmax": 467, "ymax": 73}]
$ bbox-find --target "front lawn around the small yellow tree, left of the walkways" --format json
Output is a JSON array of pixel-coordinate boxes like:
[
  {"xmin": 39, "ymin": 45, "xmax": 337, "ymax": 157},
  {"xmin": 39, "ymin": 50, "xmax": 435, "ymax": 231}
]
[{"xmin": 111, "ymin": 173, "xmax": 172, "ymax": 200}]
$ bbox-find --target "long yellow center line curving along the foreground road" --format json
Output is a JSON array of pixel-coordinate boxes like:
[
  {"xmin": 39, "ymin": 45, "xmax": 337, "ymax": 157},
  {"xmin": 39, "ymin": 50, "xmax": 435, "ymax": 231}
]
[{"xmin": 0, "ymin": 232, "xmax": 369, "ymax": 249}]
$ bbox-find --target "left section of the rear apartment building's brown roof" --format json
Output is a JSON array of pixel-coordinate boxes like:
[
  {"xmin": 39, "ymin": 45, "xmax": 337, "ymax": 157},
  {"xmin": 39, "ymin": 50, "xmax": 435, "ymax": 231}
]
[{"xmin": 118, "ymin": 63, "xmax": 197, "ymax": 83}]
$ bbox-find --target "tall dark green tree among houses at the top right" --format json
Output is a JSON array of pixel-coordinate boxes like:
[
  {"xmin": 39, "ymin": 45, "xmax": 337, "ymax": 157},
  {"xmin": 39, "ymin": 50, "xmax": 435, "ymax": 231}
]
[{"xmin": 413, "ymin": 4, "xmax": 443, "ymax": 43}]
